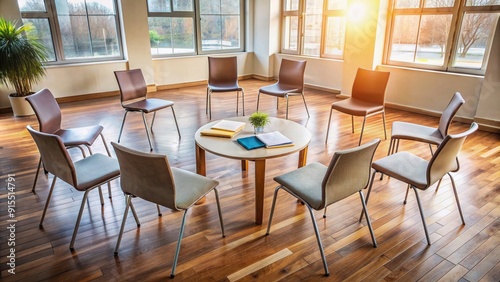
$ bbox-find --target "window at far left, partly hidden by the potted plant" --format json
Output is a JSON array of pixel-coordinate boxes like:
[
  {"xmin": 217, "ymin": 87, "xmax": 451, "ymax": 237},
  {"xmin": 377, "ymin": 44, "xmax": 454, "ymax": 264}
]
[{"xmin": 18, "ymin": 0, "xmax": 123, "ymax": 63}]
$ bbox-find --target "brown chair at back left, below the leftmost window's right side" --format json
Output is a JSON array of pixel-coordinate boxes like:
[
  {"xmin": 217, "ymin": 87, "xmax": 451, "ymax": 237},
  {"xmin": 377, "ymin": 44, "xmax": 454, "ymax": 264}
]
[{"xmin": 114, "ymin": 69, "xmax": 181, "ymax": 151}]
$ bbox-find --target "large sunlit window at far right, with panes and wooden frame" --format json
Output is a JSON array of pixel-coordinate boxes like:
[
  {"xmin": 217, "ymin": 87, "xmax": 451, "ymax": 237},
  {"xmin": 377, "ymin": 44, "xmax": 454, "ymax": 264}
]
[{"xmin": 386, "ymin": 0, "xmax": 500, "ymax": 74}]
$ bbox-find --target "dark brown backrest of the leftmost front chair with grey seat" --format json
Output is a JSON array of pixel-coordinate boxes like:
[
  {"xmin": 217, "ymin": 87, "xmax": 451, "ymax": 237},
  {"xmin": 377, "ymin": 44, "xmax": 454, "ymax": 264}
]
[{"xmin": 26, "ymin": 125, "xmax": 76, "ymax": 187}]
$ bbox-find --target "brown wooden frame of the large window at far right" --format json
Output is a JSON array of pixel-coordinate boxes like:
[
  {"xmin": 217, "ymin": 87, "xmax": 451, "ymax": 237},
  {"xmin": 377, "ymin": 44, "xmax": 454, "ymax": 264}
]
[{"xmin": 383, "ymin": 0, "xmax": 500, "ymax": 75}]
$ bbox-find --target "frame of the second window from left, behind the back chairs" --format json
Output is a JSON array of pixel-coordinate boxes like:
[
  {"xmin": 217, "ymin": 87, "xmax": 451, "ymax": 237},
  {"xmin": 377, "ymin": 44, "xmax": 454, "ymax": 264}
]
[{"xmin": 146, "ymin": 0, "xmax": 246, "ymax": 58}]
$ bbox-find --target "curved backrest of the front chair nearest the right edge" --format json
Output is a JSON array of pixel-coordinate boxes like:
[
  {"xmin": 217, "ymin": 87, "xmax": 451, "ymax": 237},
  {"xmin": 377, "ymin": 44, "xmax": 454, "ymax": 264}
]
[{"xmin": 427, "ymin": 122, "xmax": 478, "ymax": 187}]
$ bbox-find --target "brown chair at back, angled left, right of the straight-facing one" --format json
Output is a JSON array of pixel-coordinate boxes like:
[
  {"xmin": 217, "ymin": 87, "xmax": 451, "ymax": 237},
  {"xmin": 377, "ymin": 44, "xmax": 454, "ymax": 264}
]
[{"xmin": 257, "ymin": 59, "xmax": 311, "ymax": 119}]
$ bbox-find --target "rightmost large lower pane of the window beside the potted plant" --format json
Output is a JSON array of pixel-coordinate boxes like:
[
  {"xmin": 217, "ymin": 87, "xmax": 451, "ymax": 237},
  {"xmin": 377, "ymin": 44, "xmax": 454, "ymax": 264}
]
[{"xmin": 89, "ymin": 16, "xmax": 120, "ymax": 57}]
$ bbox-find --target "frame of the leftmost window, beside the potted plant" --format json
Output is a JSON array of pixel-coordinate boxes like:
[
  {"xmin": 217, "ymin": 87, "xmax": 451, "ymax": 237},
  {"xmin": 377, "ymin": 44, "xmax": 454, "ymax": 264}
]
[{"xmin": 19, "ymin": 0, "xmax": 124, "ymax": 65}]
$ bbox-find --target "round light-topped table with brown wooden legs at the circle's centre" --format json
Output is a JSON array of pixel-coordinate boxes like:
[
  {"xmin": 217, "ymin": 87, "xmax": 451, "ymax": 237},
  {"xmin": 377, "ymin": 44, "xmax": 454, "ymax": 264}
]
[{"xmin": 195, "ymin": 117, "xmax": 311, "ymax": 224}]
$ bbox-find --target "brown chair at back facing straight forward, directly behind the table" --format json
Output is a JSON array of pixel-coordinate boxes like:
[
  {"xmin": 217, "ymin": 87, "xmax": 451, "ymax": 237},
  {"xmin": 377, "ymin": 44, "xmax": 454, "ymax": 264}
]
[{"xmin": 205, "ymin": 57, "xmax": 245, "ymax": 120}]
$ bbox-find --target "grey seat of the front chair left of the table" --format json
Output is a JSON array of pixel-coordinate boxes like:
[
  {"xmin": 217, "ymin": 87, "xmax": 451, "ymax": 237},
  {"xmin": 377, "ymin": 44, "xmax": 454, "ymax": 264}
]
[{"xmin": 171, "ymin": 167, "xmax": 219, "ymax": 210}]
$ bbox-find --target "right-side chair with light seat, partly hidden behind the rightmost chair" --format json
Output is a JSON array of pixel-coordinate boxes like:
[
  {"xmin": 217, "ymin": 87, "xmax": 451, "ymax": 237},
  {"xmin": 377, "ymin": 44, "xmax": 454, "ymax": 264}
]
[{"xmin": 387, "ymin": 92, "xmax": 465, "ymax": 155}]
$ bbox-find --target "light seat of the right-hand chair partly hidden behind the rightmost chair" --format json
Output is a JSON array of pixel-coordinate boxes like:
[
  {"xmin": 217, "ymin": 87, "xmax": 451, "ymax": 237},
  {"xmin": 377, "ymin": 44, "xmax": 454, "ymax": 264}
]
[{"xmin": 391, "ymin": 121, "xmax": 444, "ymax": 145}]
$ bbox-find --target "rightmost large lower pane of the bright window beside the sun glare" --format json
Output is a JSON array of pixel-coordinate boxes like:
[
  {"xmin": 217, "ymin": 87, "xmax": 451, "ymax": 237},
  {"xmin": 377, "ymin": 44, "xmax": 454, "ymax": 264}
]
[{"xmin": 325, "ymin": 17, "xmax": 346, "ymax": 57}]
